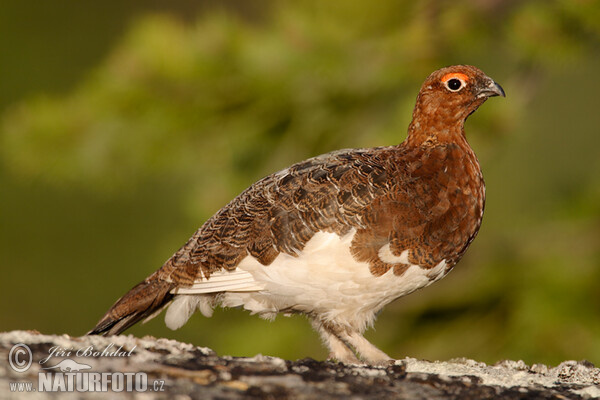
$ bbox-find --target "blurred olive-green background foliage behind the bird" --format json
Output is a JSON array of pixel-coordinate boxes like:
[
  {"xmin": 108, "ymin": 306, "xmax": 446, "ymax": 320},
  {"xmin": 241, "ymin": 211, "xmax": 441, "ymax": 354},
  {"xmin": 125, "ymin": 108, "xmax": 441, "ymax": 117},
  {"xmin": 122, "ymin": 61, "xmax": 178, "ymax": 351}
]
[{"xmin": 0, "ymin": 0, "xmax": 600, "ymax": 364}]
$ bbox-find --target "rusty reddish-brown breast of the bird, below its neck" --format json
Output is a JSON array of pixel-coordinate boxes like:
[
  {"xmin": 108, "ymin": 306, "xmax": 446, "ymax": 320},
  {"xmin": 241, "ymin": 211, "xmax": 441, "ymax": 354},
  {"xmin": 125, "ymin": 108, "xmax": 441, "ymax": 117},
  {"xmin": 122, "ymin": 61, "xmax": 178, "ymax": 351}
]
[{"xmin": 352, "ymin": 144, "xmax": 485, "ymax": 276}]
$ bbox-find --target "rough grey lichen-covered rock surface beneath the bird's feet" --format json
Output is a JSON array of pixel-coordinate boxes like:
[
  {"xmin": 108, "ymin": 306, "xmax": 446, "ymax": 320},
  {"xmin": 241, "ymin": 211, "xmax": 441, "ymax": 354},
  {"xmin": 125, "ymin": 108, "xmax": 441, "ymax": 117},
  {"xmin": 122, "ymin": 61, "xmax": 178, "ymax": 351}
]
[{"xmin": 0, "ymin": 331, "xmax": 600, "ymax": 400}]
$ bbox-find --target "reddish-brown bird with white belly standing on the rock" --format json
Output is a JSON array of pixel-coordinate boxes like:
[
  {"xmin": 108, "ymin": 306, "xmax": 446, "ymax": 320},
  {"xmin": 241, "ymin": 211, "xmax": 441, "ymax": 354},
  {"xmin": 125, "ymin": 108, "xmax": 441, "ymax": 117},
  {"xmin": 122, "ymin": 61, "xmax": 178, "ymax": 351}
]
[{"xmin": 88, "ymin": 65, "xmax": 505, "ymax": 365}]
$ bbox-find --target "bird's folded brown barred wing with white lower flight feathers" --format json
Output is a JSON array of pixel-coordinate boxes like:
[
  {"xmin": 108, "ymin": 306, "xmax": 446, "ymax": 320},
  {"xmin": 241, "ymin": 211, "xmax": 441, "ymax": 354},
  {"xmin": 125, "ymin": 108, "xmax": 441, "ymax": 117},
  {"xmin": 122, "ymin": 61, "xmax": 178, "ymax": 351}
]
[{"xmin": 155, "ymin": 147, "xmax": 398, "ymax": 293}]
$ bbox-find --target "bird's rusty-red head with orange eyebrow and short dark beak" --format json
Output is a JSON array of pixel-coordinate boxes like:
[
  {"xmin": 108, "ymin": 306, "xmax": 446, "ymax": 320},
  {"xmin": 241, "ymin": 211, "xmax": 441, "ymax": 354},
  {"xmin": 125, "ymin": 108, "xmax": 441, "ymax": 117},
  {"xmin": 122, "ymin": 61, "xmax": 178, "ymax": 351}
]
[{"xmin": 409, "ymin": 65, "xmax": 504, "ymax": 140}]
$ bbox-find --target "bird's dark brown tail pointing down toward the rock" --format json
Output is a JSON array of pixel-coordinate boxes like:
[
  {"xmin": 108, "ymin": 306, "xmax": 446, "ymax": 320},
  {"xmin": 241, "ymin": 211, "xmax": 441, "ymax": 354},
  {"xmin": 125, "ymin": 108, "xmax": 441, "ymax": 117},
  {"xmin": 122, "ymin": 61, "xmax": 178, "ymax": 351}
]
[{"xmin": 87, "ymin": 279, "xmax": 173, "ymax": 335}]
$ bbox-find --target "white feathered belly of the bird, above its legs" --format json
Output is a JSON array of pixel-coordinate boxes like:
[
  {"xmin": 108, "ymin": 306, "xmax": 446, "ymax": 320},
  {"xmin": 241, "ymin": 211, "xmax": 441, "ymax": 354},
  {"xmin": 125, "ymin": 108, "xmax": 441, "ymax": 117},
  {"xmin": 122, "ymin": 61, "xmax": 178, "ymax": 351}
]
[{"xmin": 166, "ymin": 230, "xmax": 446, "ymax": 332}]
